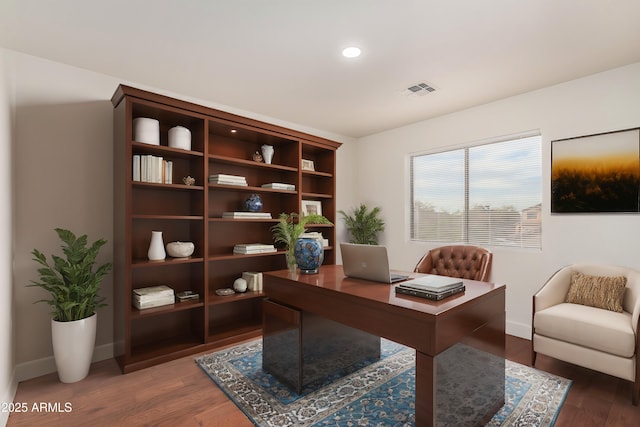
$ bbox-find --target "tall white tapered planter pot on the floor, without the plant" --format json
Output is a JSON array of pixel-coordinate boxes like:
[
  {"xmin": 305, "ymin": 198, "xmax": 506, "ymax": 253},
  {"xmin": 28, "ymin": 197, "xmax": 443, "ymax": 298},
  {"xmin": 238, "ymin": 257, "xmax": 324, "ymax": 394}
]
[{"xmin": 51, "ymin": 313, "xmax": 98, "ymax": 383}]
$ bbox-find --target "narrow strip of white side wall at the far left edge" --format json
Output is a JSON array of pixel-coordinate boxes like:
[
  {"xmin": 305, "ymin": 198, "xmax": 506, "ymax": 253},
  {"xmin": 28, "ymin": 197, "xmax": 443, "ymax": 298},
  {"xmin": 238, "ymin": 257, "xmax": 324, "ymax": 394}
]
[{"xmin": 0, "ymin": 49, "xmax": 16, "ymax": 425}]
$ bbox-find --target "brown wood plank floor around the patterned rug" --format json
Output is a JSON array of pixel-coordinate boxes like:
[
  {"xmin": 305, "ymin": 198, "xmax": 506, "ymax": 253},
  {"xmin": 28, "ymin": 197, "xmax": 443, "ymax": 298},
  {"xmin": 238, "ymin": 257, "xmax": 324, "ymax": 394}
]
[{"xmin": 7, "ymin": 336, "xmax": 640, "ymax": 427}]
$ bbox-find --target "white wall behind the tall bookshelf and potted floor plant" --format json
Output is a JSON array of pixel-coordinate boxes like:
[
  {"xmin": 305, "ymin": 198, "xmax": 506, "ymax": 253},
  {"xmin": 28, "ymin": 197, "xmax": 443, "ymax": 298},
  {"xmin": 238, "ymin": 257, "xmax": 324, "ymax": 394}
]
[{"xmin": 0, "ymin": 49, "xmax": 353, "ymax": 382}]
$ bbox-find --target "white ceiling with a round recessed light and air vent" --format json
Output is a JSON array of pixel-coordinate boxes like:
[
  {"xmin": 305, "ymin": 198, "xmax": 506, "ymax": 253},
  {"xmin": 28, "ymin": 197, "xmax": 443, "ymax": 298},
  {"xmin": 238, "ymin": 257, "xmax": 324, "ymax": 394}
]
[{"xmin": 0, "ymin": 0, "xmax": 640, "ymax": 137}]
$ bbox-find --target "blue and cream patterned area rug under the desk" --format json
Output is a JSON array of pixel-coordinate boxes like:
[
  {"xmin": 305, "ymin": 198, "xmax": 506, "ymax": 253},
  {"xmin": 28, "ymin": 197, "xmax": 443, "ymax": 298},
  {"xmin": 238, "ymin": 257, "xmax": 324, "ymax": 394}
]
[{"xmin": 196, "ymin": 339, "xmax": 571, "ymax": 427}]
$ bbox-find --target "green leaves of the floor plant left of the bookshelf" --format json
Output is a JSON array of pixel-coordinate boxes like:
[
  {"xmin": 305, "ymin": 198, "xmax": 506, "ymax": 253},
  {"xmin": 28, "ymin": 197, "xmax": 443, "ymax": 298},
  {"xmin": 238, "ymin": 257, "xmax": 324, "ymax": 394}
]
[{"xmin": 27, "ymin": 228, "xmax": 112, "ymax": 322}]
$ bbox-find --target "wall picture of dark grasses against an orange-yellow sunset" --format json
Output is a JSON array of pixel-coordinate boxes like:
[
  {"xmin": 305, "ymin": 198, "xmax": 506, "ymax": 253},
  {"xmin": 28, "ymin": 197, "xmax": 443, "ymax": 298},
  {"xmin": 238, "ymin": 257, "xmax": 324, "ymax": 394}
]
[{"xmin": 551, "ymin": 128, "xmax": 640, "ymax": 213}]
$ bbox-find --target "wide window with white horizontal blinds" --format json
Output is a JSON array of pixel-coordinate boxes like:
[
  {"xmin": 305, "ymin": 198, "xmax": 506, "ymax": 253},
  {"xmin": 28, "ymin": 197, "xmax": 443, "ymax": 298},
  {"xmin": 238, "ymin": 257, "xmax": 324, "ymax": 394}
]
[{"xmin": 410, "ymin": 134, "xmax": 542, "ymax": 249}]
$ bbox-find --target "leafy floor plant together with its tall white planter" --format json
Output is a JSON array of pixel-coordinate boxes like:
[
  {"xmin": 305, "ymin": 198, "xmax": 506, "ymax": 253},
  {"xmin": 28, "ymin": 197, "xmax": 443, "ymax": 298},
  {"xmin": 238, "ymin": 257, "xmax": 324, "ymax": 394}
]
[{"xmin": 28, "ymin": 228, "xmax": 112, "ymax": 383}]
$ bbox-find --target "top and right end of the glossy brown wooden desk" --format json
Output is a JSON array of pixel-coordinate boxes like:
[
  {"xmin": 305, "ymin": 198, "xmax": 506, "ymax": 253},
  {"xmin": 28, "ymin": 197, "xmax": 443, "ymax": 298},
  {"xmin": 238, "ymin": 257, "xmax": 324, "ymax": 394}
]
[{"xmin": 263, "ymin": 265, "xmax": 506, "ymax": 427}]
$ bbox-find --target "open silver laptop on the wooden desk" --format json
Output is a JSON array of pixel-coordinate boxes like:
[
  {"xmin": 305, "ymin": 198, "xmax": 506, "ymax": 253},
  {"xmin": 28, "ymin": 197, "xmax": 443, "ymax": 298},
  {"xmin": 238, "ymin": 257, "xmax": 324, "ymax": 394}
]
[{"xmin": 340, "ymin": 243, "xmax": 409, "ymax": 283}]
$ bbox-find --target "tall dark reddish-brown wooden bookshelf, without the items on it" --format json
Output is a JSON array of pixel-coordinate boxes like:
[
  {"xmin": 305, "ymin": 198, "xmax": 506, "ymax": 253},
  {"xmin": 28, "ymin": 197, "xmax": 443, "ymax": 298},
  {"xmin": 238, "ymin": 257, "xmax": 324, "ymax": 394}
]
[{"xmin": 111, "ymin": 85, "xmax": 340, "ymax": 373}]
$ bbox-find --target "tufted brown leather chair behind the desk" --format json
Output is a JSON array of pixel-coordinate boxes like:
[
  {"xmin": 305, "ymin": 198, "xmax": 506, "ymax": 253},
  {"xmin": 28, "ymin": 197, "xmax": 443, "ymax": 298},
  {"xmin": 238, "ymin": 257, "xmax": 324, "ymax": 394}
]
[{"xmin": 413, "ymin": 245, "xmax": 493, "ymax": 282}]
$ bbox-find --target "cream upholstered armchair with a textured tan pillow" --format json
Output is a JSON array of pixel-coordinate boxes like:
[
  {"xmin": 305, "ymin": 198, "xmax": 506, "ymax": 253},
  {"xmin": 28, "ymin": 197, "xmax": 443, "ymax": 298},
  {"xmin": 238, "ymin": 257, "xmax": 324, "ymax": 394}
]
[{"xmin": 531, "ymin": 264, "xmax": 640, "ymax": 405}]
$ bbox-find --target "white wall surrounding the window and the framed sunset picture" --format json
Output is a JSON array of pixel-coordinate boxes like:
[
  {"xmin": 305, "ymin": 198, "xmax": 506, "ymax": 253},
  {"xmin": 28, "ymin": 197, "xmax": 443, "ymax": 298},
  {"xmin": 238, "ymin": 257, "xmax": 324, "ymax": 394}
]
[{"xmin": 358, "ymin": 63, "xmax": 640, "ymax": 338}]
